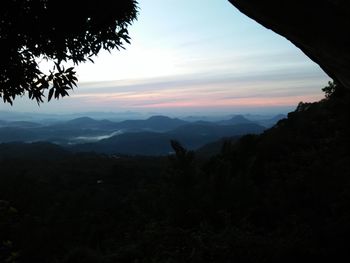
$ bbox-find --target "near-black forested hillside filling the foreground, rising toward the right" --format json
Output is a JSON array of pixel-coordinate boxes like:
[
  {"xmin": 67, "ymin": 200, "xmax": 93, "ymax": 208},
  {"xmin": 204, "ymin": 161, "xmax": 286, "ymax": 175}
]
[{"xmin": 0, "ymin": 83, "xmax": 350, "ymax": 263}]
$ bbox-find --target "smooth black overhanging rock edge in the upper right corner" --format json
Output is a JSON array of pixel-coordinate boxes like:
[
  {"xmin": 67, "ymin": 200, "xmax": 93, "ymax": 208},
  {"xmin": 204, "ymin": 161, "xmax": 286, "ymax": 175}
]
[{"xmin": 229, "ymin": 0, "xmax": 350, "ymax": 89}]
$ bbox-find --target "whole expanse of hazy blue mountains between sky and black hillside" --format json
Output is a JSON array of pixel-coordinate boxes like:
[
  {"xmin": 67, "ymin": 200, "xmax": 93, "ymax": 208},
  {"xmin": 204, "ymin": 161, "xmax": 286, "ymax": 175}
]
[{"xmin": 0, "ymin": 115, "xmax": 280, "ymax": 155}]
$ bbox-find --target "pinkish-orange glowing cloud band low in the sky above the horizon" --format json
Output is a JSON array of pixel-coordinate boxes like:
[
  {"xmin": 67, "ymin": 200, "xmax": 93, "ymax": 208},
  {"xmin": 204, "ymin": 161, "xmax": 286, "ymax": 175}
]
[{"xmin": 69, "ymin": 84, "xmax": 322, "ymax": 109}]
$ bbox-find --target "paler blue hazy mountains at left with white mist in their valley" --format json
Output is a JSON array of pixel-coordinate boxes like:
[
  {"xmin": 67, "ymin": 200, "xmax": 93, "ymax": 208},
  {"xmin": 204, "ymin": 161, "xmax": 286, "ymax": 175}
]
[{"xmin": 0, "ymin": 116, "xmax": 186, "ymax": 143}]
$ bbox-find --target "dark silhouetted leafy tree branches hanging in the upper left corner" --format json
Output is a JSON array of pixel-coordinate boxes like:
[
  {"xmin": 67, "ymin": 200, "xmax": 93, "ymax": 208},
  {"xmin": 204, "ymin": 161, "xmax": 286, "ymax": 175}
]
[{"xmin": 0, "ymin": 0, "xmax": 137, "ymax": 104}]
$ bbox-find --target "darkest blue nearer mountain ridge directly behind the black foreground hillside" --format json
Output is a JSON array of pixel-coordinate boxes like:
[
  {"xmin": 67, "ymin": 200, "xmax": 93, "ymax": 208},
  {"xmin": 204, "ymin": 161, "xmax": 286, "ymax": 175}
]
[{"xmin": 71, "ymin": 123, "xmax": 264, "ymax": 155}]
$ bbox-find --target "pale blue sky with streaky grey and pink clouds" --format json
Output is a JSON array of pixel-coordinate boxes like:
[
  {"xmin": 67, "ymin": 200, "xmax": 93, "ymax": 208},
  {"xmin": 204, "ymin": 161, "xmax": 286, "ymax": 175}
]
[{"xmin": 0, "ymin": 0, "xmax": 329, "ymax": 115}]
